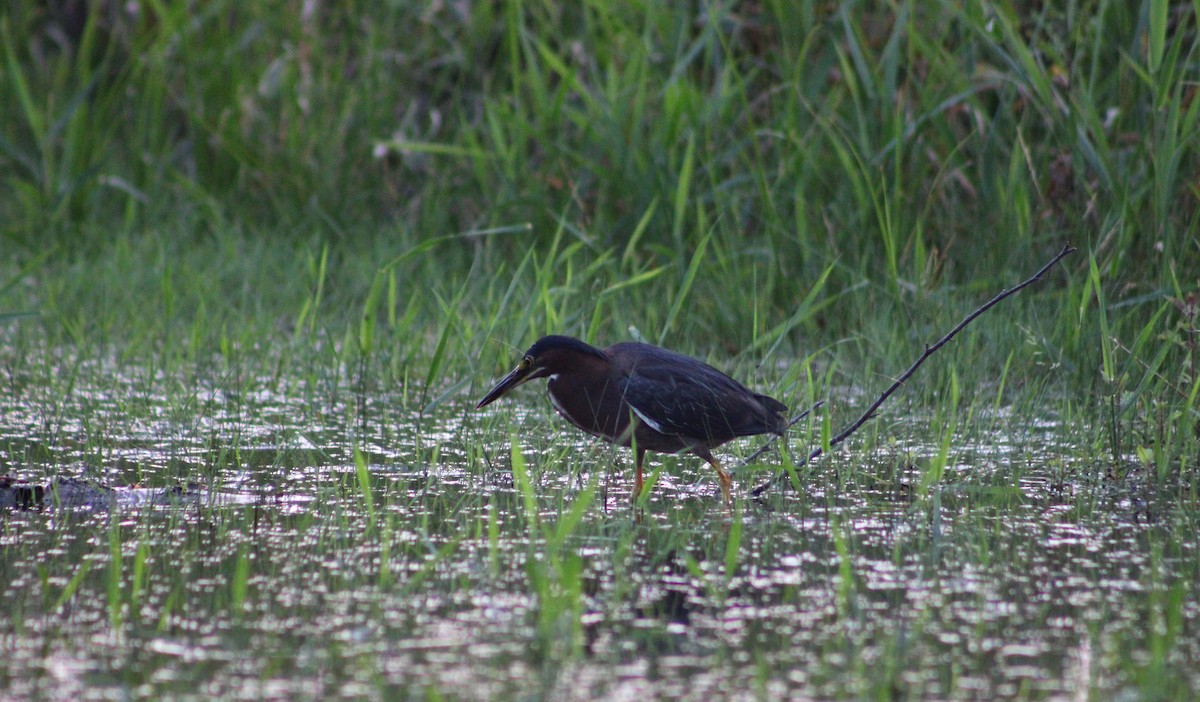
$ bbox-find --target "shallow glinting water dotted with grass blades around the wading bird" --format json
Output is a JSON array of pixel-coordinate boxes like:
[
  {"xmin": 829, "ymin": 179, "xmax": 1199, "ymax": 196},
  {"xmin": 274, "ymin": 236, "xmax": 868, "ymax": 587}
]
[{"xmin": 0, "ymin": 357, "xmax": 1200, "ymax": 700}]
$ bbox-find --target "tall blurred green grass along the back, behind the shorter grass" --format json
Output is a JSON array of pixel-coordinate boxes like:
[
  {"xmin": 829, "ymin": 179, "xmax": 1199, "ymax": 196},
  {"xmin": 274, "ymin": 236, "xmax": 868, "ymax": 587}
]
[{"xmin": 0, "ymin": 0, "xmax": 1198, "ymax": 271}]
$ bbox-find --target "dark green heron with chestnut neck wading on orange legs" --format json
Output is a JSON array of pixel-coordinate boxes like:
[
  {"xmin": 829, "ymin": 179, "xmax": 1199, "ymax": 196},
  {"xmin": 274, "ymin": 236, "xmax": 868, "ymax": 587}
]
[{"xmin": 475, "ymin": 336, "xmax": 787, "ymax": 505}]
